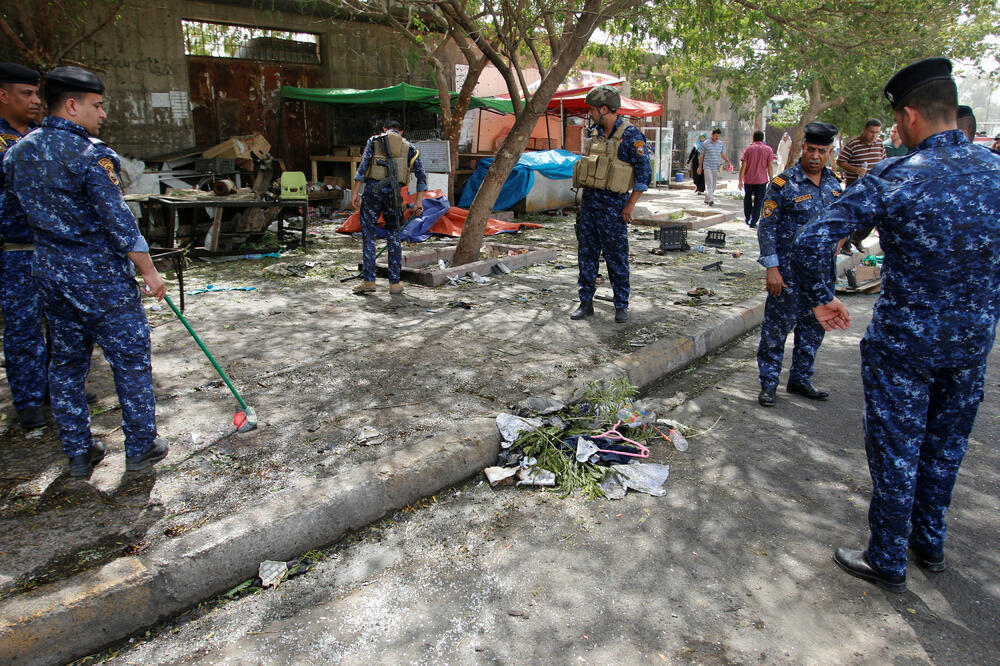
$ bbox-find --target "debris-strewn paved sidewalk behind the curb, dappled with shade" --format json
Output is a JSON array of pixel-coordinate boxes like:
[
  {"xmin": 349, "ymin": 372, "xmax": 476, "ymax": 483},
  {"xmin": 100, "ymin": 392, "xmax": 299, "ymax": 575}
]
[{"xmin": 0, "ymin": 179, "xmax": 763, "ymax": 599}]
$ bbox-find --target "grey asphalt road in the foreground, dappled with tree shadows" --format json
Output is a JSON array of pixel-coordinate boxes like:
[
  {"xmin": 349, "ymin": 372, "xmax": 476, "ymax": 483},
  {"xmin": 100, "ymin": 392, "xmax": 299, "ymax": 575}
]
[{"xmin": 95, "ymin": 296, "xmax": 1000, "ymax": 664}]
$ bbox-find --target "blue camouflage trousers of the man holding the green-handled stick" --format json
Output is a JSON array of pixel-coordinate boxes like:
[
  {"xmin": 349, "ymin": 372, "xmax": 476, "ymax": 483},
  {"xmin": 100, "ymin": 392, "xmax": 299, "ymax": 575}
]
[{"xmin": 38, "ymin": 279, "xmax": 156, "ymax": 457}]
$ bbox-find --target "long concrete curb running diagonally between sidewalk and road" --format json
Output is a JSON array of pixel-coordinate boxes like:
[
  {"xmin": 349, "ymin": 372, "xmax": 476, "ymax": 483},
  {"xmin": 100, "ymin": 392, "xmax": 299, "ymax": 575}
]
[{"xmin": 0, "ymin": 295, "xmax": 764, "ymax": 666}]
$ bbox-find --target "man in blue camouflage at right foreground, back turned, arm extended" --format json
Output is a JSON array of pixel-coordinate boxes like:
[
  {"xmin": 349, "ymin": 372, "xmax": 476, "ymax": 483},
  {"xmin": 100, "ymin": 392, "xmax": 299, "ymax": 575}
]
[{"xmin": 793, "ymin": 58, "xmax": 1000, "ymax": 592}]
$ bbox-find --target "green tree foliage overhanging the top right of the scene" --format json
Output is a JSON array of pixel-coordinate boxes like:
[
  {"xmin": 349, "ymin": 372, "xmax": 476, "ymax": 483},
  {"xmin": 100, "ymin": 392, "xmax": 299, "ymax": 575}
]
[{"xmin": 590, "ymin": 0, "xmax": 1000, "ymax": 130}]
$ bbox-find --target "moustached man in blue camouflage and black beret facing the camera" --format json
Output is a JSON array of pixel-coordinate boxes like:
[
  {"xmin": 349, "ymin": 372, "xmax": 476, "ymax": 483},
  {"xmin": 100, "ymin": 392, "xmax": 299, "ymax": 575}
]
[{"xmin": 757, "ymin": 123, "xmax": 841, "ymax": 407}]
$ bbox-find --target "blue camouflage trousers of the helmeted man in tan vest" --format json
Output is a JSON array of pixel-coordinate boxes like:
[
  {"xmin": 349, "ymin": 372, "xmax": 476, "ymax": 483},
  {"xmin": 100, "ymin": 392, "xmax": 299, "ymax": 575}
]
[{"xmin": 576, "ymin": 188, "xmax": 630, "ymax": 309}]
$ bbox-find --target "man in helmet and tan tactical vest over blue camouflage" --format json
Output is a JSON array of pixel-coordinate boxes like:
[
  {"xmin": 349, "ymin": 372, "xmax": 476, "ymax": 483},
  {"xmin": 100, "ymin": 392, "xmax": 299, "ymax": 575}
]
[{"xmin": 570, "ymin": 86, "xmax": 653, "ymax": 324}]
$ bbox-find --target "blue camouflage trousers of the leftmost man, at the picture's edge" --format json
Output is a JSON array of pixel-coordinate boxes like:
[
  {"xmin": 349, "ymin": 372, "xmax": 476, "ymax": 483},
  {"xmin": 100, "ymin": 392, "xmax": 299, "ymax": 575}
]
[{"xmin": 0, "ymin": 251, "xmax": 49, "ymax": 411}]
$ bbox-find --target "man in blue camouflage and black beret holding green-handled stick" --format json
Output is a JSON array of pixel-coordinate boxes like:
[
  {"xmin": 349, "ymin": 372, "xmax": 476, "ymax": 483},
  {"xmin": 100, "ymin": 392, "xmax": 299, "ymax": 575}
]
[{"xmin": 4, "ymin": 67, "xmax": 168, "ymax": 477}]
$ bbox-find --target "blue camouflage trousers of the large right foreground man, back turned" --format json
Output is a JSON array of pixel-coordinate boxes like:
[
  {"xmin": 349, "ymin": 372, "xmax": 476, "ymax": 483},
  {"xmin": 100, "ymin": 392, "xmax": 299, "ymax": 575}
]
[{"xmin": 861, "ymin": 340, "xmax": 986, "ymax": 576}]
